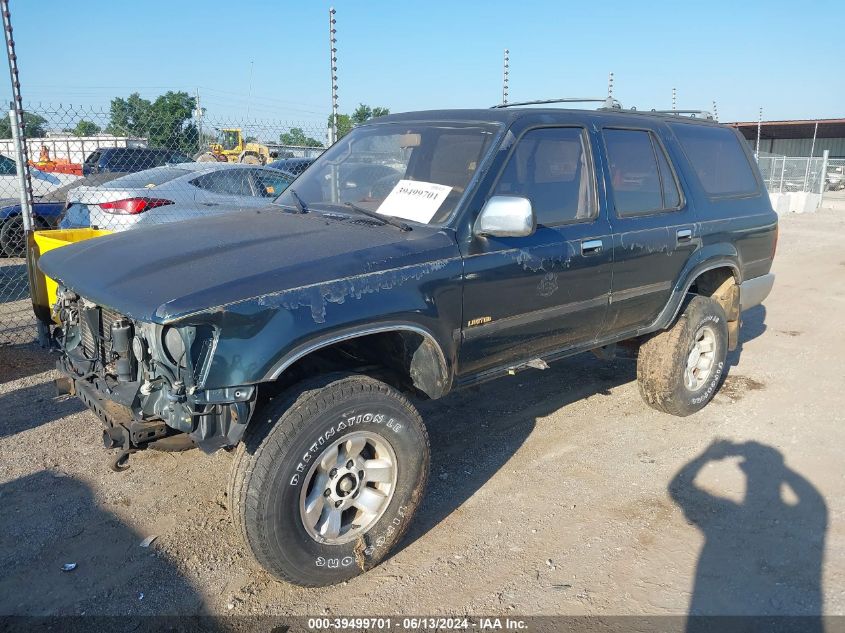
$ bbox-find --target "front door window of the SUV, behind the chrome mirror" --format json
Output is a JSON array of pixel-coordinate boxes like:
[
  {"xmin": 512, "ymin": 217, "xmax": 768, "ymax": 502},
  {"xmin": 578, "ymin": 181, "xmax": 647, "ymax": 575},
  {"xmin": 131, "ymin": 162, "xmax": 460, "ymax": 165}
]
[{"xmin": 495, "ymin": 128, "xmax": 597, "ymax": 226}]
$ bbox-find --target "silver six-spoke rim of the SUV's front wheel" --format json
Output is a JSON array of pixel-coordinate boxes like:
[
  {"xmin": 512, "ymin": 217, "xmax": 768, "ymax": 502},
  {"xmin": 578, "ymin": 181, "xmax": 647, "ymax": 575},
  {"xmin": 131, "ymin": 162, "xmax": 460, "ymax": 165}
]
[{"xmin": 299, "ymin": 431, "xmax": 397, "ymax": 545}]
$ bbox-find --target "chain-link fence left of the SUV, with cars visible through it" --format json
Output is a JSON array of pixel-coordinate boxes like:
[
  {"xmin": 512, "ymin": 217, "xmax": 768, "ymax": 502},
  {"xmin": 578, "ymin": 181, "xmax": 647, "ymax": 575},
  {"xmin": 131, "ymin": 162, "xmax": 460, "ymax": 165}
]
[{"xmin": 0, "ymin": 101, "xmax": 328, "ymax": 345}]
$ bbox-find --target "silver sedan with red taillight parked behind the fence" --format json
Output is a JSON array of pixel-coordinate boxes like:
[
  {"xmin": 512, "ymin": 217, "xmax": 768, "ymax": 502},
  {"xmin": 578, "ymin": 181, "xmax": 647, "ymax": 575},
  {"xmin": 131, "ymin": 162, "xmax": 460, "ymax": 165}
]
[{"xmin": 60, "ymin": 163, "xmax": 293, "ymax": 231}]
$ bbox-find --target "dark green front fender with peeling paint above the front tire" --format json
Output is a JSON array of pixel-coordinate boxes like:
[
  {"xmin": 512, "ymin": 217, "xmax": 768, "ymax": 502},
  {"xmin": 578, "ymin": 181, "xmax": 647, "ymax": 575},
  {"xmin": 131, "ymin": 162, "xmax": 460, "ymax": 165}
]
[{"xmin": 198, "ymin": 257, "xmax": 463, "ymax": 390}]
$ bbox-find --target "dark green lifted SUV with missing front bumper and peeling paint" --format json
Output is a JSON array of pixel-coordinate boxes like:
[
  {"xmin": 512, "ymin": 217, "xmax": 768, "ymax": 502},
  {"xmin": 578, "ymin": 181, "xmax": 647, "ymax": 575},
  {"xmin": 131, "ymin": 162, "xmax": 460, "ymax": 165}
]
[{"xmin": 40, "ymin": 108, "xmax": 778, "ymax": 586}]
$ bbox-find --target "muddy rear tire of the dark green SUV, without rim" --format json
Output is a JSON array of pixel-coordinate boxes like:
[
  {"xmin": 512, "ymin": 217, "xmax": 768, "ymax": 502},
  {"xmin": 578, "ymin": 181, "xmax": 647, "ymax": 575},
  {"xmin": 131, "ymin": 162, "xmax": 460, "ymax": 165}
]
[{"xmin": 637, "ymin": 296, "xmax": 728, "ymax": 417}]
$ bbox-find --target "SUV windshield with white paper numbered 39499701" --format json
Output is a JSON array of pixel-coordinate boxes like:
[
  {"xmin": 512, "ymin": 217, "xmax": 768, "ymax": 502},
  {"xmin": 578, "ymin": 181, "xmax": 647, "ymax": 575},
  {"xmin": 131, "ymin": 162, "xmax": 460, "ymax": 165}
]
[{"xmin": 276, "ymin": 123, "xmax": 499, "ymax": 224}]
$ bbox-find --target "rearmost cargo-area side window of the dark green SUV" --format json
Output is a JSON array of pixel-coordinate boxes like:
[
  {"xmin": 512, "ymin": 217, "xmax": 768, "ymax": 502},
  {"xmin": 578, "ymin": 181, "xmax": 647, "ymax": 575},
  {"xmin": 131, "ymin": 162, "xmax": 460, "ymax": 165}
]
[{"xmin": 672, "ymin": 123, "xmax": 760, "ymax": 196}]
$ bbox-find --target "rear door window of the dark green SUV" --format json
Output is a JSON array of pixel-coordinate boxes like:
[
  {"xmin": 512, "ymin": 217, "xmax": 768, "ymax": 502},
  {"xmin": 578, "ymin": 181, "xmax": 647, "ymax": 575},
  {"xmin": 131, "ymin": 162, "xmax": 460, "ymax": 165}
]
[{"xmin": 603, "ymin": 129, "xmax": 681, "ymax": 217}]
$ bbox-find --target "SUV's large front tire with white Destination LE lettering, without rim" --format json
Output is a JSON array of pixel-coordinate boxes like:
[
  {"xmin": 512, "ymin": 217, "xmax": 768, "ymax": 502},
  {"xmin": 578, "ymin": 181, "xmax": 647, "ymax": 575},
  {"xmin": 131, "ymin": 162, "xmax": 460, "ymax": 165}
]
[{"xmin": 228, "ymin": 373, "xmax": 429, "ymax": 587}]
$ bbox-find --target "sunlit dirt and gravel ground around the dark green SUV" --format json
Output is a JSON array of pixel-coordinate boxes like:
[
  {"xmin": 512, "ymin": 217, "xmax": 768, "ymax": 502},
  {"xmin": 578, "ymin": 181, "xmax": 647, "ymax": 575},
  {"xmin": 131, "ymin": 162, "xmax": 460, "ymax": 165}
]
[{"xmin": 0, "ymin": 207, "xmax": 845, "ymax": 615}]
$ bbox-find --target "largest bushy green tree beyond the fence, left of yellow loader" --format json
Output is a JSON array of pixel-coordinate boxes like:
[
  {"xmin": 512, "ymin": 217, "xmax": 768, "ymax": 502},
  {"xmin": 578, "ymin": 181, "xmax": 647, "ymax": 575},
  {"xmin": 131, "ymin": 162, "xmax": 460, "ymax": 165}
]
[{"xmin": 106, "ymin": 91, "xmax": 198, "ymax": 151}]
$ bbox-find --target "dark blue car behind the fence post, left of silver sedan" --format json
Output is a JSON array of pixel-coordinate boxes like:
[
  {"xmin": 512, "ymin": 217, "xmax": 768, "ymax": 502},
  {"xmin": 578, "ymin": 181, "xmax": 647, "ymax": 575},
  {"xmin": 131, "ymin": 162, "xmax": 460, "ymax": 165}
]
[{"xmin": 0, "ymin": 173, "xmax": 122, "ymax": 257}]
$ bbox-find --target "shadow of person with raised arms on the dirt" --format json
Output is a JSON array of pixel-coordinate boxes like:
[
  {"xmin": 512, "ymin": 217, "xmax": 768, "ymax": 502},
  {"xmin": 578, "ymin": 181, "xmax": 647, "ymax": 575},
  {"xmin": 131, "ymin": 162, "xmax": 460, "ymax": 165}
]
[{"xmin": 669, "ymin": 440, "xmax": 828, "ymax": 632}]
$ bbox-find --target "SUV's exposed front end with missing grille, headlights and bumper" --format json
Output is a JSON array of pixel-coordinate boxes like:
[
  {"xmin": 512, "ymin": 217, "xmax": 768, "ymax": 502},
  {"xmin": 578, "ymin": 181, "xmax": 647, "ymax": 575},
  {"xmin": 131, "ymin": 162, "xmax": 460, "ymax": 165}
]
[{"xmin": 53, "ymin": 286, "xmax": 257, "ymax": 470}]
